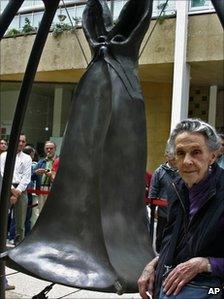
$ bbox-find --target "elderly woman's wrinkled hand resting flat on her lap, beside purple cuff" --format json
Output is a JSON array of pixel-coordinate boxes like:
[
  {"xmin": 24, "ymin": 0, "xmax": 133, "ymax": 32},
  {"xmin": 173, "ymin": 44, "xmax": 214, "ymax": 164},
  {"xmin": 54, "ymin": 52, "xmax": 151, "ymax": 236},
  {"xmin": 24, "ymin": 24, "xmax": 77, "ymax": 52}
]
[{"xmin": 163, "ymin": 257, "xmax": 209, "ymax": 296}]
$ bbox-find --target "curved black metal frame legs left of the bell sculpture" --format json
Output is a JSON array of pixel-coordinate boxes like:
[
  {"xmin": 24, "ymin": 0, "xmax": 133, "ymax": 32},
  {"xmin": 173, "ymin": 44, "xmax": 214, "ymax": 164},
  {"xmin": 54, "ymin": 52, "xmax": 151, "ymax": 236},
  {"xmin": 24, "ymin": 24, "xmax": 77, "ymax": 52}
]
[{"xmin": 0, "ymin": 0, "xmax": 59, "ymax": 299}]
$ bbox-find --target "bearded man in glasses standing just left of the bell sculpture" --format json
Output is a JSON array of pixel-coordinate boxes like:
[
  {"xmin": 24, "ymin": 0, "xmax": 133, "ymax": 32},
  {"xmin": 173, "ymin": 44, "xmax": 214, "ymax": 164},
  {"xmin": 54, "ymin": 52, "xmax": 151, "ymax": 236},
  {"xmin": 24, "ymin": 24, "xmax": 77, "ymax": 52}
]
[{"xmin": 33, "ymin": 141, "xmax": 57, "ymax": 213}]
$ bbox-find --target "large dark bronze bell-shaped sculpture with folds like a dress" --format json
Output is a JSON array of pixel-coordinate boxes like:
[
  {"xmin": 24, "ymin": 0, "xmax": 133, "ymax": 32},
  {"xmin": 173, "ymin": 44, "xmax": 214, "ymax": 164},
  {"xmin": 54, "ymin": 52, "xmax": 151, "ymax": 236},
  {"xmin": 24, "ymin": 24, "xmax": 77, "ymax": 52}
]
[{"xmin": 8, "ymin": 0, "xmax": 154, "ymax": 293}]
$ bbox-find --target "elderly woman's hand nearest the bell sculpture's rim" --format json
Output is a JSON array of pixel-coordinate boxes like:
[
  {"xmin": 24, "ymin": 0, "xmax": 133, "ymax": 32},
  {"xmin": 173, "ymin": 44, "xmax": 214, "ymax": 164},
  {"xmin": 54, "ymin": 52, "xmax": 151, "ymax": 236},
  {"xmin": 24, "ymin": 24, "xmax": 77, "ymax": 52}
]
[{"xmin": 138, "ymin": 257, "xmax": 158, "ymax": 299}]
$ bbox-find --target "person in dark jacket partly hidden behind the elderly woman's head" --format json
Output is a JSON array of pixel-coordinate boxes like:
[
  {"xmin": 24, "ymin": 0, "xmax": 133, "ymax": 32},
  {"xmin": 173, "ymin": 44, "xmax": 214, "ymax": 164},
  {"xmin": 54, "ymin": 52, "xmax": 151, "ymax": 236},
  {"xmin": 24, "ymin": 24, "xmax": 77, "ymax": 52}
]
[{"xmin": 149, "ymin": 146, "xmax": 179, "ymax": 252}]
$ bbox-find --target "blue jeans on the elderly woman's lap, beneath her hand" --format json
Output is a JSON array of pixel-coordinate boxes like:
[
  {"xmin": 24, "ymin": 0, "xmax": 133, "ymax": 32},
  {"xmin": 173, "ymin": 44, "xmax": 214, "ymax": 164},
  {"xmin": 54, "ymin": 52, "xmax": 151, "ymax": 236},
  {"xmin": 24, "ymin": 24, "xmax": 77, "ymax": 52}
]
[{"xmin": 159, "ymin": 277, "xmax": 223, "ymax": 299}]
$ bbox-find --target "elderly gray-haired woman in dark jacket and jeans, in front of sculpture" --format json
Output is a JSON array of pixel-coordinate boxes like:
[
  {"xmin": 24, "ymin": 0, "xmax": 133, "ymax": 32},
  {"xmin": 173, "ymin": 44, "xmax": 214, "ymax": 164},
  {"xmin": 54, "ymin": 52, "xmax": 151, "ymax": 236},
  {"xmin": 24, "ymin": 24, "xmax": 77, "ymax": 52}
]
[{"xmin": 138, "ymin": 119, "xmax": 224, "ymax": 299}]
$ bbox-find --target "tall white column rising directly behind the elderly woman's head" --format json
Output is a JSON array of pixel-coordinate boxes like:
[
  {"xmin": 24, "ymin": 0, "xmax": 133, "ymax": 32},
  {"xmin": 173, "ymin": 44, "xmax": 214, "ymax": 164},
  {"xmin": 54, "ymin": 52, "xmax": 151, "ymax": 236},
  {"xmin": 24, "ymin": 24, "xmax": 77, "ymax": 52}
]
[{"xmin": 170, "ymin": 0, "xmax": 190, "ymax": 130}]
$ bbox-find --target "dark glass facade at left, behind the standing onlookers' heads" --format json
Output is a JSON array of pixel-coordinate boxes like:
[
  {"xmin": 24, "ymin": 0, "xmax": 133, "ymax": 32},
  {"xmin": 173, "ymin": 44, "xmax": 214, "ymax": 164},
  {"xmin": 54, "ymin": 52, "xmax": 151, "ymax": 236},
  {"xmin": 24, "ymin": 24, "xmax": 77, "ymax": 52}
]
[{"xmin": 0, "ymin": 82, "xmax": 76, "ymax": 156}]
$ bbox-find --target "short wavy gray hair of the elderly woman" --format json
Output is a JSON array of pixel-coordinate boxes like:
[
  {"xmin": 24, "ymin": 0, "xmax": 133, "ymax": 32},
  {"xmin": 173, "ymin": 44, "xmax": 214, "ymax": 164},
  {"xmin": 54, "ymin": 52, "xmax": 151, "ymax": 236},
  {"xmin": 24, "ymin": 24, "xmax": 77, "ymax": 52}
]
[{"xmin": 167, "ymin": 118, "xmax": 221, "ymax": 154}]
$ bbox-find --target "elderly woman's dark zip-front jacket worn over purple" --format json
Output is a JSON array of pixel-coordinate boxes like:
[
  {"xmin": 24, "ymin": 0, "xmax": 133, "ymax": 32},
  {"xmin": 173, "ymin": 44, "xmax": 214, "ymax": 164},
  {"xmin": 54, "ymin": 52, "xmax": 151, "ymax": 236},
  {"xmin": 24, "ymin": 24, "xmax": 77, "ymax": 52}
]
[{"xmin": 153, "ymin": 164, "xmax": 224, "ymax": 299}]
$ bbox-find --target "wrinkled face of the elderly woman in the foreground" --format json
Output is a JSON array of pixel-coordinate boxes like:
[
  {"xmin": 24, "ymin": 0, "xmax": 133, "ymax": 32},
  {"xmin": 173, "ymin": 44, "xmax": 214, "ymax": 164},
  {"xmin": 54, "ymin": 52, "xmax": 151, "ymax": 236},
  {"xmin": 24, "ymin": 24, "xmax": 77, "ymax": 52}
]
[{"xmin": 175, "ymin": 132, "xmax": 216, "ymax": 188}]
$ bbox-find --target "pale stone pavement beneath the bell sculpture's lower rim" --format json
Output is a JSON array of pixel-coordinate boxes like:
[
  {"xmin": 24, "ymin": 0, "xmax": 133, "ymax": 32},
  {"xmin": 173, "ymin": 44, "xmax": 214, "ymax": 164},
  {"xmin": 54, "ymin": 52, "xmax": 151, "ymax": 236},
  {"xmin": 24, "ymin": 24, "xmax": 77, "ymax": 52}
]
[{"xmin": 6, "ymin": 268, "xmax": 140, "ymax": 299}]
